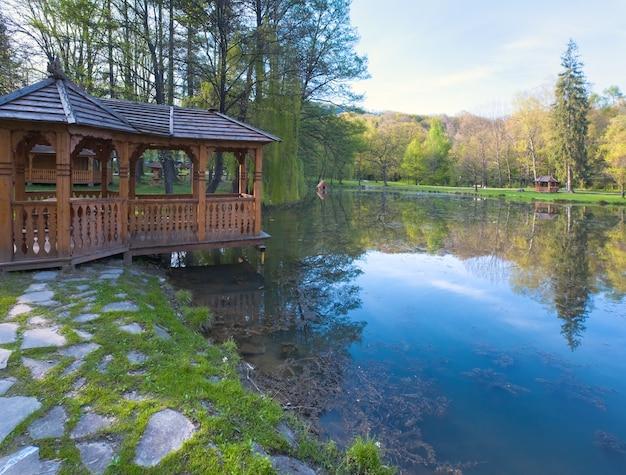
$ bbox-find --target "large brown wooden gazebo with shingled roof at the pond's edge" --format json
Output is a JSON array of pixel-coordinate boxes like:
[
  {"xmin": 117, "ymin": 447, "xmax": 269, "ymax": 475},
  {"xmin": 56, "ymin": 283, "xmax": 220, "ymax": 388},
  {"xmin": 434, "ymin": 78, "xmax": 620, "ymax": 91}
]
[{"xmin": 0, "ymin": 70, "xmax": 279, "ymax": 273}]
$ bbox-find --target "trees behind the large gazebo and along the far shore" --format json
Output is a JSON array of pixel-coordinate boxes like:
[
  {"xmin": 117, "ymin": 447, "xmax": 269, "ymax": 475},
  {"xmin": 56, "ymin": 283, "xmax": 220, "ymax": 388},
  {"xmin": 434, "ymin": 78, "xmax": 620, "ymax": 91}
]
[{"xmin": 0, "ymin": 0, "xmax": 626, "ymax": 204}]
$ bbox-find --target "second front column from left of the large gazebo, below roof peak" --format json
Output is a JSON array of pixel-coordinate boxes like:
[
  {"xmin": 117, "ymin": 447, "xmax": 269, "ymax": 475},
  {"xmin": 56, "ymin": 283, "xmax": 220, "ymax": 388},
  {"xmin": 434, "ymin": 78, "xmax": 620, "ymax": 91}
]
[{"xmin": 55, "ymin": 130, "xmax": 72, "ymax": 257}]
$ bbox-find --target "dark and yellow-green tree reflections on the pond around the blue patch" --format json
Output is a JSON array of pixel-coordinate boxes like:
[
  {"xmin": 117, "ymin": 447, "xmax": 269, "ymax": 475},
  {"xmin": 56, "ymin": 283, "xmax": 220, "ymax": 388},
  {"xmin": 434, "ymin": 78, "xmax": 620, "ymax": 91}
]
[{"xmin": 165, "ymin": 192, "xmax": 626, "ymax": 473}]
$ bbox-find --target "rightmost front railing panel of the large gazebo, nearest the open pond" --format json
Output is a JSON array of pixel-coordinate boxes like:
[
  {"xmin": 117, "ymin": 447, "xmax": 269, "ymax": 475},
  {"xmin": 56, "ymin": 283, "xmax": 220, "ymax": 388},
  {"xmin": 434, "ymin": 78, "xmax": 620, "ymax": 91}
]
[{"xmin": 205, "ymin": 195, "xmax": 255, "ymax": 241}]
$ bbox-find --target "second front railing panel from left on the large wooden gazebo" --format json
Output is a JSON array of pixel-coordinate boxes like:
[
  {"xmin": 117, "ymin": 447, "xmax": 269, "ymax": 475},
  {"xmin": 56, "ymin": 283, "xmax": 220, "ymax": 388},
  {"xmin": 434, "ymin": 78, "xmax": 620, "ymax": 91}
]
[{"xmin": 70, "ymin": 198, "xmax": 125, "ymax": 256}]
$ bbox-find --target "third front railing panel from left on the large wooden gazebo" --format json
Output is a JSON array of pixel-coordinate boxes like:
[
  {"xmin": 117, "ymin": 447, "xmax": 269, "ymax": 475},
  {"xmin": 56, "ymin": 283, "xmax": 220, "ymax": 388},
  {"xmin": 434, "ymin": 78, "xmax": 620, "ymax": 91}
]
[{"xmin": 128, "ymin": 198, "xmax": 198, "ymax": 249}]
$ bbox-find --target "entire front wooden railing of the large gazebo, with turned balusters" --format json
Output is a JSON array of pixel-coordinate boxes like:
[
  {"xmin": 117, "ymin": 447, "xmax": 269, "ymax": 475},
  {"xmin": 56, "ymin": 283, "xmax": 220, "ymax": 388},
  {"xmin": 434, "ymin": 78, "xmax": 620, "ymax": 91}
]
[{"xmin": 12, "ymin": 192, "xmax": 258, "ymax": 268}]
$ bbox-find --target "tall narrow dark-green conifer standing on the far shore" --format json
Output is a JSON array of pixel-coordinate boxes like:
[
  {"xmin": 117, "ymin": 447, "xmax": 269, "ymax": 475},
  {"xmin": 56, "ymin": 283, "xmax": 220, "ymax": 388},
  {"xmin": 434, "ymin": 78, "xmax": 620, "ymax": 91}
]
[{"xmin": 553, "ymin": 40, "xmax": 590, "ymax": 193}]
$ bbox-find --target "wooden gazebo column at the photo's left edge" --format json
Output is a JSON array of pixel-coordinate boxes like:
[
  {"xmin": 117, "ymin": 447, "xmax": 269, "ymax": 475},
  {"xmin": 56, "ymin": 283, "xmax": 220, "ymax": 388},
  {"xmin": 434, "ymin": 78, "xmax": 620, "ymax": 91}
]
[{"xmin": 0, "ymin": 129, "xmax": 13, "ymax": 262}]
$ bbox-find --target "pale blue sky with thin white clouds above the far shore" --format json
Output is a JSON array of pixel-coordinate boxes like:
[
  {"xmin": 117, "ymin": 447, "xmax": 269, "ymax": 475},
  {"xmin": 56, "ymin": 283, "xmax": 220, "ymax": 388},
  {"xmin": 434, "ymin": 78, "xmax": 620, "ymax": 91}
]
[{"xmin": 351, "ymin": 0, "xmax": 626, "ymax": 116}]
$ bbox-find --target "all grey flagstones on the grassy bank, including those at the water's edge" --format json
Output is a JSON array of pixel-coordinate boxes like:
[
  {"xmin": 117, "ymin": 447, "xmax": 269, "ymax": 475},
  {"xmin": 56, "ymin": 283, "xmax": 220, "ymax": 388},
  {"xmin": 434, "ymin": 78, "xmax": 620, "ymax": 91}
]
[{"xmin": 0, "ymin": 266, "xmax": 315, "ymax": 475}]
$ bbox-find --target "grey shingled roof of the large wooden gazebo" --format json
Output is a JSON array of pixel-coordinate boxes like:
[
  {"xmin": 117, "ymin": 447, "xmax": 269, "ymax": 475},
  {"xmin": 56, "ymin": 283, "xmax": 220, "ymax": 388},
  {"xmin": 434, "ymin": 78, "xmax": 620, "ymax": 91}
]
[{"xmin": 0, "ymin": 75, "xmax": 280, "ymax": 143}]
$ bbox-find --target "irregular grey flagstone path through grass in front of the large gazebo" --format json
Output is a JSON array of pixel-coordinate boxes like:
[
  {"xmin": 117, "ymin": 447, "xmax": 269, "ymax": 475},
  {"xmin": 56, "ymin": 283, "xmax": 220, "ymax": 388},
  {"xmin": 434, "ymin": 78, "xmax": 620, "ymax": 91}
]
[{"xmin": 0, "ymin": 267, "xmax": 195, "ymax": 475}]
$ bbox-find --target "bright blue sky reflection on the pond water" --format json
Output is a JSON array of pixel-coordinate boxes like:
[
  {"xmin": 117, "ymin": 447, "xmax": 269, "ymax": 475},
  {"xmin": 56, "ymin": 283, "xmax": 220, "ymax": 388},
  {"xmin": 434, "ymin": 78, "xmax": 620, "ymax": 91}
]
[{"xmin": 342, "ymin": 251, "xmax": 626, "ymax": 475}]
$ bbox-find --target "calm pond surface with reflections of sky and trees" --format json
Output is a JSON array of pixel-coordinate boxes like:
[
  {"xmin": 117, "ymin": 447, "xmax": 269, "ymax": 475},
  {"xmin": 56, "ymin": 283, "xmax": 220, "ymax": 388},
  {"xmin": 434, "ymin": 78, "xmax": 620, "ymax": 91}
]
[{"xmin": 166, "ymin": 192, "xmax": 626, "ymax": 475}]
